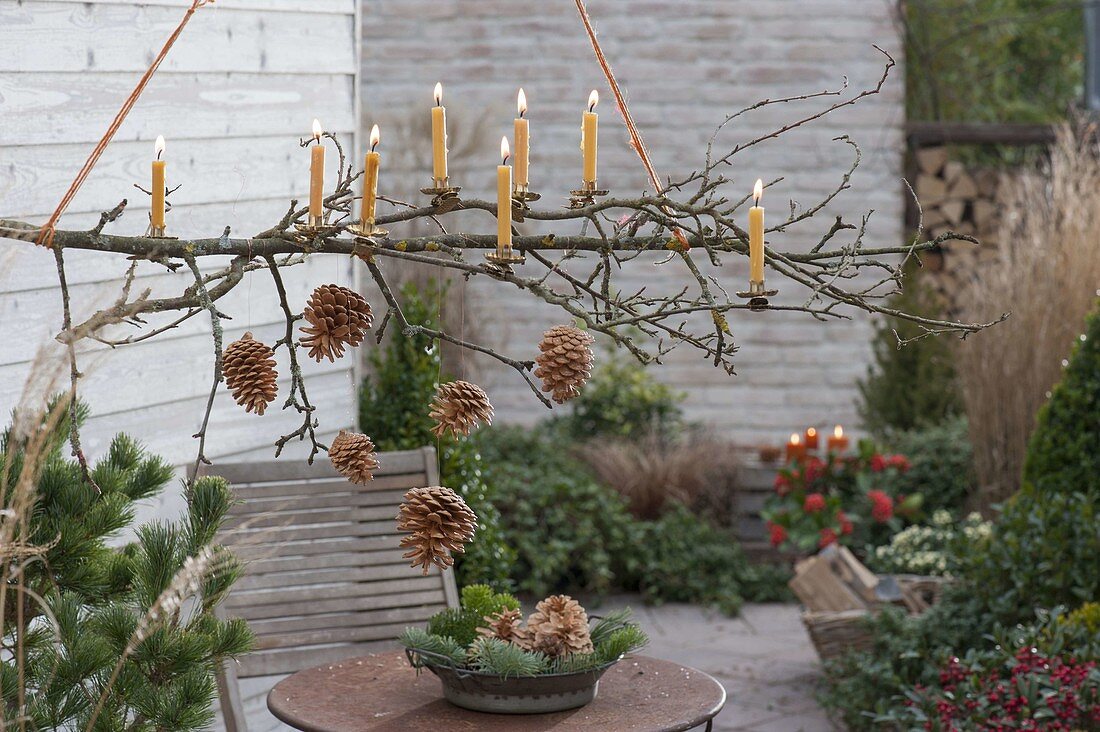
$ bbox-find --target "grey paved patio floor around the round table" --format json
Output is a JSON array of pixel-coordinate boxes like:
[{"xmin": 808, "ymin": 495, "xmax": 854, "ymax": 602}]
[{"xmin": 218, "ymin": 596, "xmax": 835, "ymax": 732}]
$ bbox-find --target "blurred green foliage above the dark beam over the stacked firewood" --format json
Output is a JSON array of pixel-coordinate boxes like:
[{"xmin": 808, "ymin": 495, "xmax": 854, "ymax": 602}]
[{"xmin": 904, "ymin": 0, "xmax": 1085, "ymax": 122}]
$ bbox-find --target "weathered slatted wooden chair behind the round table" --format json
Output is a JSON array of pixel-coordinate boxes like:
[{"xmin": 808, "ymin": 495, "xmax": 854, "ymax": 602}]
[{"xmin": 195, "ymin": 447, "xmax": 459, "ymax": 732}]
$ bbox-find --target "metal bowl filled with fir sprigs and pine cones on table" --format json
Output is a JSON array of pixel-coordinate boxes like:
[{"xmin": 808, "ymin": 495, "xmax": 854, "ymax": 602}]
[{"xmin": 400, "ymin": 584, "xmax": 649, "ymax": 714}]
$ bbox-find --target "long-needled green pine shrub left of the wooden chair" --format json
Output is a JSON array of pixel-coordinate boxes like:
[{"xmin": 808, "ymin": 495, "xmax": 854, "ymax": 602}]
[{"xmin": 0, "ymin": 408, "xmax": 252, "ymax": 732}]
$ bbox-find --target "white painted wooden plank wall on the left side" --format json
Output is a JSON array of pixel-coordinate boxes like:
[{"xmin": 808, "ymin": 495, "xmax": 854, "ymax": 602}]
[{"xmin": 0, "ymin": 0, "xmax": 359, "ymax": 526}]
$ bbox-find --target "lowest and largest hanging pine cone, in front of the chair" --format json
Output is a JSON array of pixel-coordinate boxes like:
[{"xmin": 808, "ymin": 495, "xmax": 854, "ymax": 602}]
[{"xmin": 397, "ymin": 485, "xmax": 477, "ymax": 575}]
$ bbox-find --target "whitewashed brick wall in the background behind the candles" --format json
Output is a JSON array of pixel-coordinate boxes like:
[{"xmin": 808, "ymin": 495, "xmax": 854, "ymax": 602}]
[{"xmin": 362, "ymin": 0, "xmax": 903, "ymax": 441}]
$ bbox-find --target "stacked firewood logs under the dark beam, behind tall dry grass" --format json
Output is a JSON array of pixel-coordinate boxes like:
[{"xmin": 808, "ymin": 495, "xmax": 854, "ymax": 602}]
[{"xmin": 914, "ymin": 146, "xmax": 1001, "ymax": 312}]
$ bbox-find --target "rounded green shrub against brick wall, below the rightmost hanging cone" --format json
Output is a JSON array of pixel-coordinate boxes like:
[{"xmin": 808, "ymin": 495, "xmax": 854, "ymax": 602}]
[{"xmin": 557, "ymin": 356, "xmax": 684, "ymax": 440}]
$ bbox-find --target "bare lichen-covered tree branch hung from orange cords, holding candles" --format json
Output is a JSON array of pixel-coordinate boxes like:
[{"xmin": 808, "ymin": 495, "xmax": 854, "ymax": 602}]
[{"xmin": 0, "ymin": 48, "xmax": 1007, "ymax": 461}]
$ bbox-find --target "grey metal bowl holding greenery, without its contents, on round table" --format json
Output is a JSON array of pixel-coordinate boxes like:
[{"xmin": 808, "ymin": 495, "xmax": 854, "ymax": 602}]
[{"xmin": 406, "ymin": 651, "xmax": 617, "ymax": 714}]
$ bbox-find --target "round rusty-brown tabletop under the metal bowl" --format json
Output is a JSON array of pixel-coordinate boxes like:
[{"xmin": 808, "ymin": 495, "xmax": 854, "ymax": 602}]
[{"xmin": 267, "ymin": 651, "xmax": 726, "ymax": 732}]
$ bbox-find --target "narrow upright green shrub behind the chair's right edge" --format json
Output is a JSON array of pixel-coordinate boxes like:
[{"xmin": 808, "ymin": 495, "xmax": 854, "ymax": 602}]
[{"xmin": 359, "ymin": 282, "xmax": 513, "ymax": 586}]
